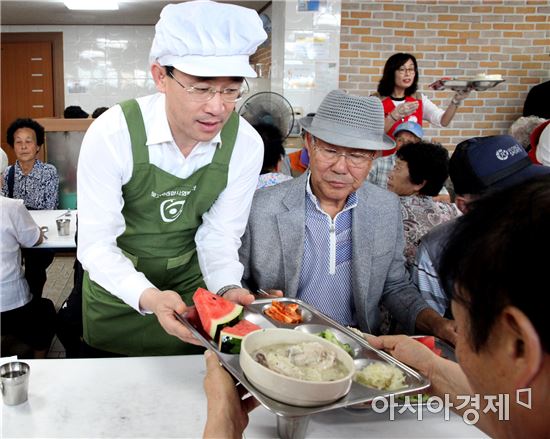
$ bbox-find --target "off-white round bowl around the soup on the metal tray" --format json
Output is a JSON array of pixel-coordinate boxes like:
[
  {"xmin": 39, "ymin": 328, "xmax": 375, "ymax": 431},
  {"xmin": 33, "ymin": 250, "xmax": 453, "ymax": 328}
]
[{"xmin": 243, "ymin": 328, "xmax": 355, "ymax": 407}]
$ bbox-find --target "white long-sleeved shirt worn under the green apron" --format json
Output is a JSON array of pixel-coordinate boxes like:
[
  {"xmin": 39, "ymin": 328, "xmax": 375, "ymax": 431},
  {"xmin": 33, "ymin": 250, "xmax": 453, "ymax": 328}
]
[{"xmin": 77, "ymin": 93, "xmax": 263, "ymax": 312}]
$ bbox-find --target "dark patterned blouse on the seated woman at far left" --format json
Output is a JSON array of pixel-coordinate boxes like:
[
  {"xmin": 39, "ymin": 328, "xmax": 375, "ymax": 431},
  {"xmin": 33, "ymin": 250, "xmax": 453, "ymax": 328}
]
[{"xmin": 2, "ymin": 160, "xmax": 59, "ymax": 210}]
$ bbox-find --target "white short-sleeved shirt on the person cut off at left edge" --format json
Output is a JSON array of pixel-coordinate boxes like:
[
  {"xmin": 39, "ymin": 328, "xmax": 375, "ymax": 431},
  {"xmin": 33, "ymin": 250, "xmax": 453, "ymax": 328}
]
[{"xmin": 0, "ymin": 196, "xmax": 40, "ymax": 312}]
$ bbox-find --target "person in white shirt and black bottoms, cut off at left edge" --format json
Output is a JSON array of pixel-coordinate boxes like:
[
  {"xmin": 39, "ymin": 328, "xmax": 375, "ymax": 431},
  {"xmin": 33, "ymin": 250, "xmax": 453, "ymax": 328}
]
[{"xmin": 0, "ymin": 196, "xmax": 55, "ymax": 358}]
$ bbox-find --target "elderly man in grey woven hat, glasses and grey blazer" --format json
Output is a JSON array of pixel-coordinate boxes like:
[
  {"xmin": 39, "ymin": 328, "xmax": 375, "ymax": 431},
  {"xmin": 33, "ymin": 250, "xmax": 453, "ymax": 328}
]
[{"xmin": 240, "ymin": 90, "xmax": 453, "ymax": 339}]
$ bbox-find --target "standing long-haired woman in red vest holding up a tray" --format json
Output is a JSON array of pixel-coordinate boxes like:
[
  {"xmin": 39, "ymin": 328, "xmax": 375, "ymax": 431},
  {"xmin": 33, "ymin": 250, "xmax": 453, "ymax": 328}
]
[{"xmin": 376, "ymin": 53, "xmax": 471, "ymax": 149}]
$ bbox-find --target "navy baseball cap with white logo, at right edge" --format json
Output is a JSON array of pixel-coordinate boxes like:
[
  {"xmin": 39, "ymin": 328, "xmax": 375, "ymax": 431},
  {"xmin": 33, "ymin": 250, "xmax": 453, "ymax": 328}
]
[{"xmin": 449, "ymin": 135, "xmax": 550, "ymax": 195}]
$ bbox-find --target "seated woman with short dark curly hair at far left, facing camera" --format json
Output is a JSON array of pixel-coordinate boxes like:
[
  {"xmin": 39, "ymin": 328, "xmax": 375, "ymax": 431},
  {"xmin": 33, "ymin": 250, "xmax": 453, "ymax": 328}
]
[{"xmin": 2, "ymin": 119, "xmax": 59, "ymax": 297}]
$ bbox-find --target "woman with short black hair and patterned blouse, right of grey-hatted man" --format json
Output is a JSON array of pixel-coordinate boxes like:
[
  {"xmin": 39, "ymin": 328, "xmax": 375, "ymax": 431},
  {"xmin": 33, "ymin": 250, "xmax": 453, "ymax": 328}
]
[{"xmin": 388, "ymin": 142, "xmax": 460, "ymax": 266}]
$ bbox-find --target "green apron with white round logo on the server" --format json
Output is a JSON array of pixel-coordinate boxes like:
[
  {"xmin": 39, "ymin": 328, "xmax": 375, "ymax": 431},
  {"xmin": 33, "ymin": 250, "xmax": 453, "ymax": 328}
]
[{"xmin": 82, "ymin": 100, "xmax": 239, "ymax": 356}]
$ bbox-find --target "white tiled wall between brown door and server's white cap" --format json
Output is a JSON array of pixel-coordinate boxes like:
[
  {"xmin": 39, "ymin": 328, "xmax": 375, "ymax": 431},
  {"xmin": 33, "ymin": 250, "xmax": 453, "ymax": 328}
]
[{"xmin": 2, "ymin": 26, "xmax": 155, "ymax": 113}]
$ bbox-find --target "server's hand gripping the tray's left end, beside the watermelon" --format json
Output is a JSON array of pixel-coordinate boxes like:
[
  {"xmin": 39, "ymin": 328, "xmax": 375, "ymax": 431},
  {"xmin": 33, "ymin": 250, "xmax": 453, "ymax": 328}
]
[{"xmin": 139, "ymin": 288, "xmax": 202, "ymax": 346}]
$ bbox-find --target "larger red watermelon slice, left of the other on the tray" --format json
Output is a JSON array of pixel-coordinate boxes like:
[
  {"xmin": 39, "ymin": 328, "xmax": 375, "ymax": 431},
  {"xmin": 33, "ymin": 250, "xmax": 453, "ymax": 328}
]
[{"xmin": 193, "ymin": 288, "xmax": 243, "ymax": 340}]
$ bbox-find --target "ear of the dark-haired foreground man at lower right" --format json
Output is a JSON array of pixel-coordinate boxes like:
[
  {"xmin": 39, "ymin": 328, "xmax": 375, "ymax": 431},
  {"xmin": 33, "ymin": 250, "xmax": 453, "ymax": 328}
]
[{"xmin": 497, "ymin": 306, "xmax": 544, "ymax": 389}]
